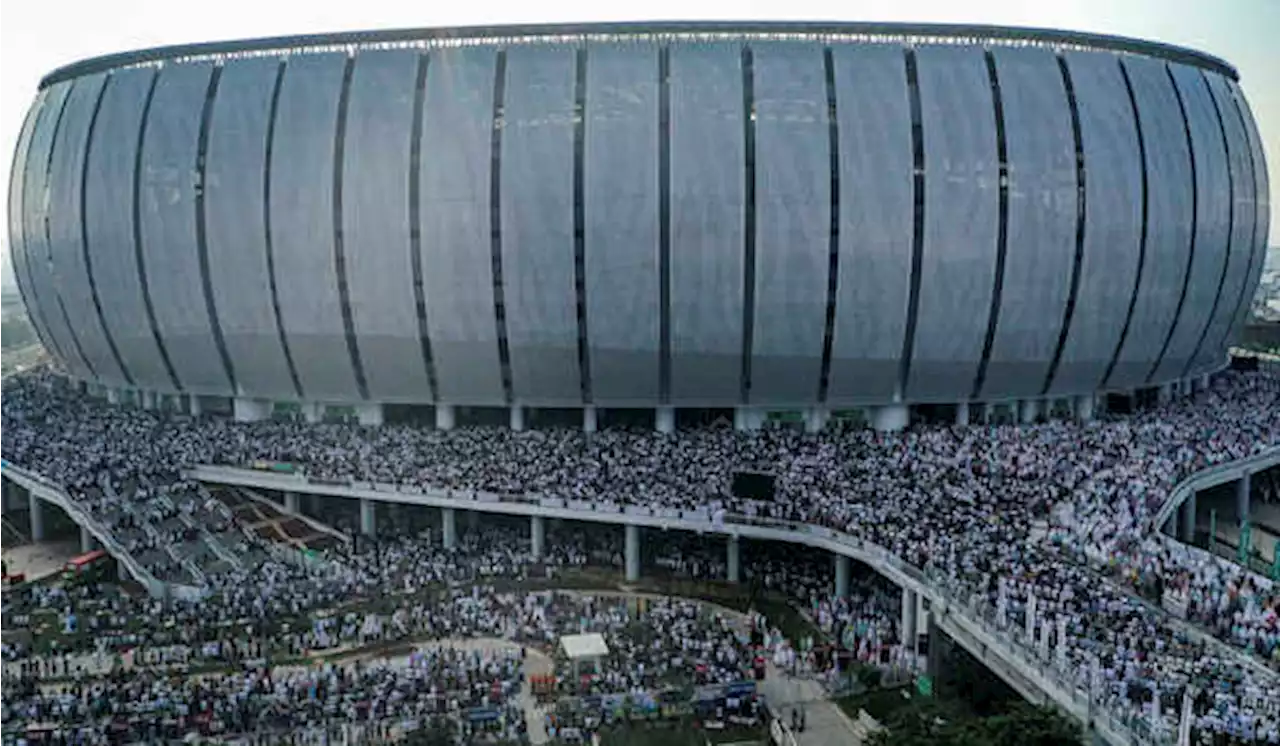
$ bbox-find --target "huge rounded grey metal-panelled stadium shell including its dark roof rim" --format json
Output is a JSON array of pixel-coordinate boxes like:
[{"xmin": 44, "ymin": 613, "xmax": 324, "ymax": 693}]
[{"xmin": 9, "ymin": 23, "xmax": 1268, "ymax": 427}]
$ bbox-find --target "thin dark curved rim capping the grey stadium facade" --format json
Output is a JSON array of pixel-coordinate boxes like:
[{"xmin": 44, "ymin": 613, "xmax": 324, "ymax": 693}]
[{"xmin": 40, "ymin": 20, "xmax": 1239, "ymax": 88}]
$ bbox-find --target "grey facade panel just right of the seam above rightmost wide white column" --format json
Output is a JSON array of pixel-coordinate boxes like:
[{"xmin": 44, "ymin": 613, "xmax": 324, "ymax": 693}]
[{"xmin": 905, "ymin": 46, "xmax": 1000, "ymax": 401}]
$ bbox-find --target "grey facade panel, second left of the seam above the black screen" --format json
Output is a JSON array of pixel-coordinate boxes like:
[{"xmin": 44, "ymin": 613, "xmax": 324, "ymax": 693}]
[{"xmin": 582, "ymin": 45, "xmax": 660, "ymax": 406}]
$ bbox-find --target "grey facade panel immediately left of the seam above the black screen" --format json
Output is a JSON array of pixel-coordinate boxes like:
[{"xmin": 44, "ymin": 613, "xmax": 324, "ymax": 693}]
[{"xmin": 669, "ymin": 44, "xmax": 745, "ymax": 406}]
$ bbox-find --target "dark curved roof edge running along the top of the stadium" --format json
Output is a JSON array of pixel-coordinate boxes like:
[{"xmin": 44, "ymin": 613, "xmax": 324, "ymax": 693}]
[{"xmin": 40, "ymin": 20, "xmax": 1239, "ymax": 88}]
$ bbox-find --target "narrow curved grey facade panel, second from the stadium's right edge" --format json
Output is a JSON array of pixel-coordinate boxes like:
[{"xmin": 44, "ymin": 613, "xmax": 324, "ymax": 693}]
[{"xmin": 1190, "ymin": 74, "xmax": 1254, "ymax": 374}]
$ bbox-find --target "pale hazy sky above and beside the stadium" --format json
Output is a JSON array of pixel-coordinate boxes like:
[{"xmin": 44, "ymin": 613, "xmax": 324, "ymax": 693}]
[{"xmin": 0, "ymin": 0, "xmax": 1280, "ymax": 284}]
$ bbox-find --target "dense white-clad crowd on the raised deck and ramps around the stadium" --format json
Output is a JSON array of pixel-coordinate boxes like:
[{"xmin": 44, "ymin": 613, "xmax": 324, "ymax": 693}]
[{"xmin": 0, "ymin": 371, "xmax": 1280, "ymax": 742}]
